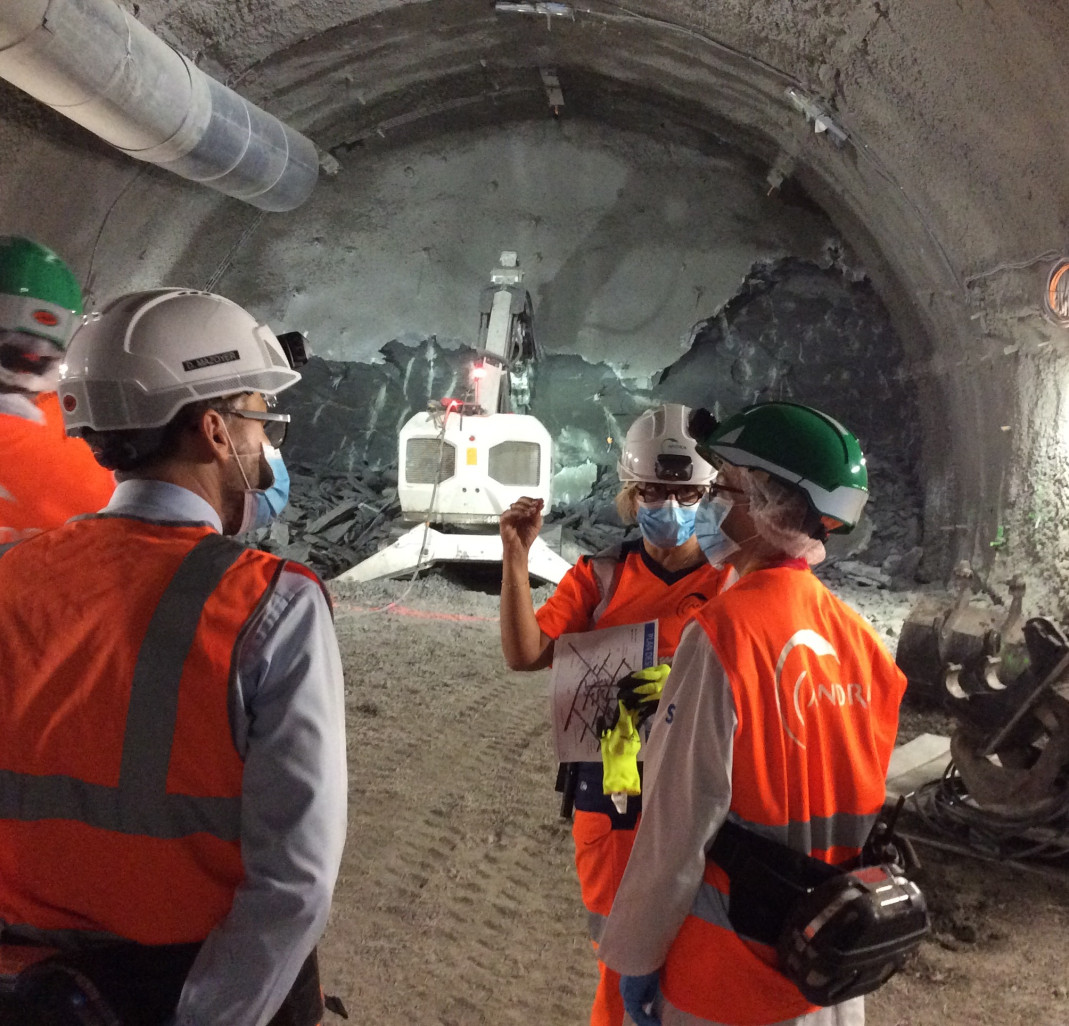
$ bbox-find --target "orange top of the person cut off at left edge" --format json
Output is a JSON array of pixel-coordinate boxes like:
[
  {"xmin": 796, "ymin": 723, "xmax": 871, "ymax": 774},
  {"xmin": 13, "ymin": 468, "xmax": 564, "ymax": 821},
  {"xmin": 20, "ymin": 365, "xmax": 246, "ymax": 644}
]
[{"xmin": 0, "ymin": 392, "xmax": 115, "ymax": 545}]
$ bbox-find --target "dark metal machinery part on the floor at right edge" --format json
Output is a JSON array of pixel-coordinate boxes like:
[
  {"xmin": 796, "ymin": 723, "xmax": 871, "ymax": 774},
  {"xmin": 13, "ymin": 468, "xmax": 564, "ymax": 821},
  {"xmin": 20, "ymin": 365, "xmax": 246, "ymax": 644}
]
[{"xmin": 897, "ymin": 564, "xmax": 1069, "ymax": 865}]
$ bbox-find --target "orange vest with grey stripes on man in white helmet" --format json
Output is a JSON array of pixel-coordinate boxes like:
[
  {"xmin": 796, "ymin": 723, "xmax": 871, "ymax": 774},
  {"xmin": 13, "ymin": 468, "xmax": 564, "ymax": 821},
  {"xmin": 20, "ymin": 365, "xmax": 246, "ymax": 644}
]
[{"xmin": 0, "ymin": 515, "xmax": 311, "ymax": 945}]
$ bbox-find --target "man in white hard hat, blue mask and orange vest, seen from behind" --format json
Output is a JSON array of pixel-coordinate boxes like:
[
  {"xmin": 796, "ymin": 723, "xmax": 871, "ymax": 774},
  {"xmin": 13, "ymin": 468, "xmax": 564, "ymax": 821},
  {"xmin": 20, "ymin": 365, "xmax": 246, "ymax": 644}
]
[{"xmin": 0, "ymin": 290, "xmax": 346, "ymax": 1026}]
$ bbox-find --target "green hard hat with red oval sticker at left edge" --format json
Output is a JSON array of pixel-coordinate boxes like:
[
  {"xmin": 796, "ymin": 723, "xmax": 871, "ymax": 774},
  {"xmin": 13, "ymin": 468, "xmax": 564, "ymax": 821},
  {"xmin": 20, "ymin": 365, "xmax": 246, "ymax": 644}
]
[{"xmin": 0, "ymin": 235, "xmax": 81, "ymax": 351}]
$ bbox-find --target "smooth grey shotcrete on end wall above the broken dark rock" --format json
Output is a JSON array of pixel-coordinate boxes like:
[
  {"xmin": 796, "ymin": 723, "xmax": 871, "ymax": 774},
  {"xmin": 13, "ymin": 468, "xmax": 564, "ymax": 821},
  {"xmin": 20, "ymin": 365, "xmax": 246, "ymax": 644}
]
[{"xmin": 220, "ymin": 116, "xmax": 839, "ymax": 377}]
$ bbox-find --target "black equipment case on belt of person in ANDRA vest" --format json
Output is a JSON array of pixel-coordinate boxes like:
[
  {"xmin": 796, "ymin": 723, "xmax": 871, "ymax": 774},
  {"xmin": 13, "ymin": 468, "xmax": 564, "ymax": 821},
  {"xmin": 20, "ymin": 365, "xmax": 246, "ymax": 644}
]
[{"xmin": 709, "ymin": 819, "xmax": 930, "ymax": 1006}]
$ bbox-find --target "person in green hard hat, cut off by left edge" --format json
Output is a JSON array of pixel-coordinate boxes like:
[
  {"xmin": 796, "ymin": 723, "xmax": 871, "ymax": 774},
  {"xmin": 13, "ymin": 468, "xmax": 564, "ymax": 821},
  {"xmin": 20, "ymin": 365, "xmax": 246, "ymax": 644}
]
[{"xmin": 0, "ymin": 235, "xmax": 115, "ymax": 545}]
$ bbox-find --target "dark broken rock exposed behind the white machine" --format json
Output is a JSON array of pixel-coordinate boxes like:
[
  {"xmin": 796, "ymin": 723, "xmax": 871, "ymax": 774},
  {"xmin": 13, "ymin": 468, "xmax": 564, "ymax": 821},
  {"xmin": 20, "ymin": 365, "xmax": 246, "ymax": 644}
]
[{"xmin": 269, "ymin": 261, "xmax": 920, "ymax": 588}]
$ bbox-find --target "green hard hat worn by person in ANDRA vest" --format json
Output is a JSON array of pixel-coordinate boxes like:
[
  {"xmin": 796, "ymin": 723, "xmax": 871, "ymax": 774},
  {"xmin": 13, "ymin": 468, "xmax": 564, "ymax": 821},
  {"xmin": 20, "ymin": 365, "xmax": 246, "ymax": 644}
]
[{"xmin": 697, "ymin": 402, "xmax": 868, "ymax": 533}]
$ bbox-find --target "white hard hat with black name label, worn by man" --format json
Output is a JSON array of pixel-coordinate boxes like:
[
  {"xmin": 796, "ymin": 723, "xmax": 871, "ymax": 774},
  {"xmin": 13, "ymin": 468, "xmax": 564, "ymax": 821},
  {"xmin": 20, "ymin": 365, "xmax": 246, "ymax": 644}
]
[{"xmin": 59, "ymin": 289, "xmax": 300, "ymax": 433}]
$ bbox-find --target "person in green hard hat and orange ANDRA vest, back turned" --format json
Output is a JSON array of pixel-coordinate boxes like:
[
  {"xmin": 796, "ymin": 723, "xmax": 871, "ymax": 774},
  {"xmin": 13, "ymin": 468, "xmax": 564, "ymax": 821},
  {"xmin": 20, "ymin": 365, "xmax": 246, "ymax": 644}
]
[{"xmin": 601, "ymin": 403, "xmax": 905, "ymax": 1026}]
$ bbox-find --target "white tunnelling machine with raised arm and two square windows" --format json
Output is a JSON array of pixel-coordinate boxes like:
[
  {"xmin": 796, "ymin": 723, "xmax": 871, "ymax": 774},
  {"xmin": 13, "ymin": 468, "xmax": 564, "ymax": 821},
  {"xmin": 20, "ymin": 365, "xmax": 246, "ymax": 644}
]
[{"xmin": 335, "ymin": 251, "xmax": 571, "ymax": 584}]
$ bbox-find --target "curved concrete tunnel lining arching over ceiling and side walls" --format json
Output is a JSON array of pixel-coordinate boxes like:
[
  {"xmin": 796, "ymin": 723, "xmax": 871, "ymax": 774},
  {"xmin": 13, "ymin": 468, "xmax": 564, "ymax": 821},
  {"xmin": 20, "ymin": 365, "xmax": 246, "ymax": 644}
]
[{"xmin": 0, "ymin": 0, "xmax": 1069, "ymax": 609}]
